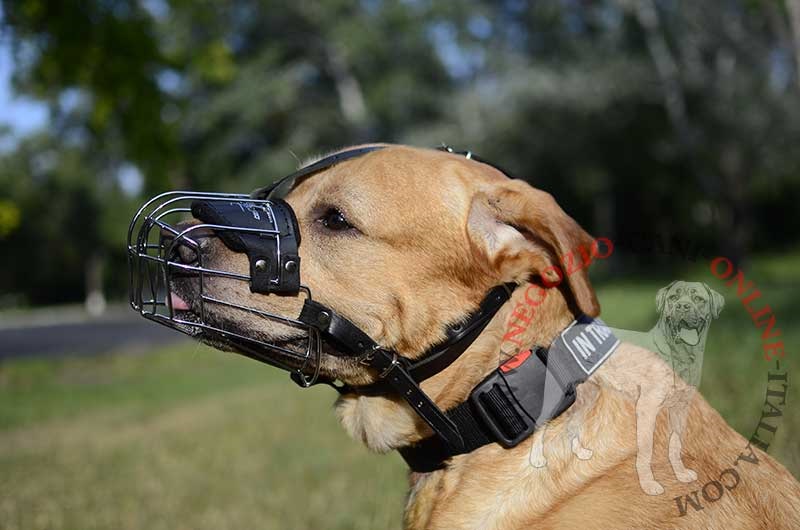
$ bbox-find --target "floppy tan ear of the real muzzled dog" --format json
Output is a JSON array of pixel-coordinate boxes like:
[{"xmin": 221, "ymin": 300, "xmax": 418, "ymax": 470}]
[{"xmin": 467, "ymin": 179, "xmax": 600, "ymax": 317}]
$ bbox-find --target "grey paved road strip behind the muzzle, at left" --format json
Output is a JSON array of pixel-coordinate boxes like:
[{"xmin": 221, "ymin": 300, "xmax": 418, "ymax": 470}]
[{"xmin": 0, "ymin": 311, "xmax": 190, "ymax": 362}]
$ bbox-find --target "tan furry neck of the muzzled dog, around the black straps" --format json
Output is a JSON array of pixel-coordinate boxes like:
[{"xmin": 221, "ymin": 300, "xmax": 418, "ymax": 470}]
[{"xmin": 336, "ymin": 284, "xmax": 575, "ymax": 453}]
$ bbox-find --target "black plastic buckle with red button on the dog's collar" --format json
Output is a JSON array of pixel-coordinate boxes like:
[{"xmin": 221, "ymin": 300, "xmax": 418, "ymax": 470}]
[{"xmin": 469, "ymin": 350, "xmax": 575, "ymax": 448}]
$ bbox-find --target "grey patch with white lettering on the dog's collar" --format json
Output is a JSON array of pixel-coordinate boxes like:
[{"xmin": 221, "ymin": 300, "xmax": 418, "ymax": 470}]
[{"xmin": 560, "ymin": 315, "xmax": 619, "ymax": 375}]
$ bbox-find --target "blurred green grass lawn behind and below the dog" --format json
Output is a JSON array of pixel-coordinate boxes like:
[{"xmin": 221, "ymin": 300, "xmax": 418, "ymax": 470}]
[{"xmin": 0, "ymin": 252, "xmax": 800, "ymax": 530}]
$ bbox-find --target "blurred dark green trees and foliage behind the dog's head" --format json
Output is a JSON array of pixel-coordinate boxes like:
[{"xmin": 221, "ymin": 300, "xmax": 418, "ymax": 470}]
[{"xmin": 0, "ymin": 0, "xmax": 800, "ymax": 305}]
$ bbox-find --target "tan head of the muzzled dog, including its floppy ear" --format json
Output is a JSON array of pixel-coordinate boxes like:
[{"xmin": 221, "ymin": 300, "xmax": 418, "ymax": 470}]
[{"xmin": 166, "ymin": 146, "xmax": 599, "ymax": 384}]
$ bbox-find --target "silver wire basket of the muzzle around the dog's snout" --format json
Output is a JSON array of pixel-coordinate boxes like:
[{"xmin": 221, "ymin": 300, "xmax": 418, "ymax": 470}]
[{"xmin": 128, "ymin": 191, "xmax": 321, "ymax": 386}]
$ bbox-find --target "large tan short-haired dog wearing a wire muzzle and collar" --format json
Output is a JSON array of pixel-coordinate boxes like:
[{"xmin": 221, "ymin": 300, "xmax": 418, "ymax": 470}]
[{"xmin": 133, "ymin": 146, "xmax": 800, "ymax": 530}]
